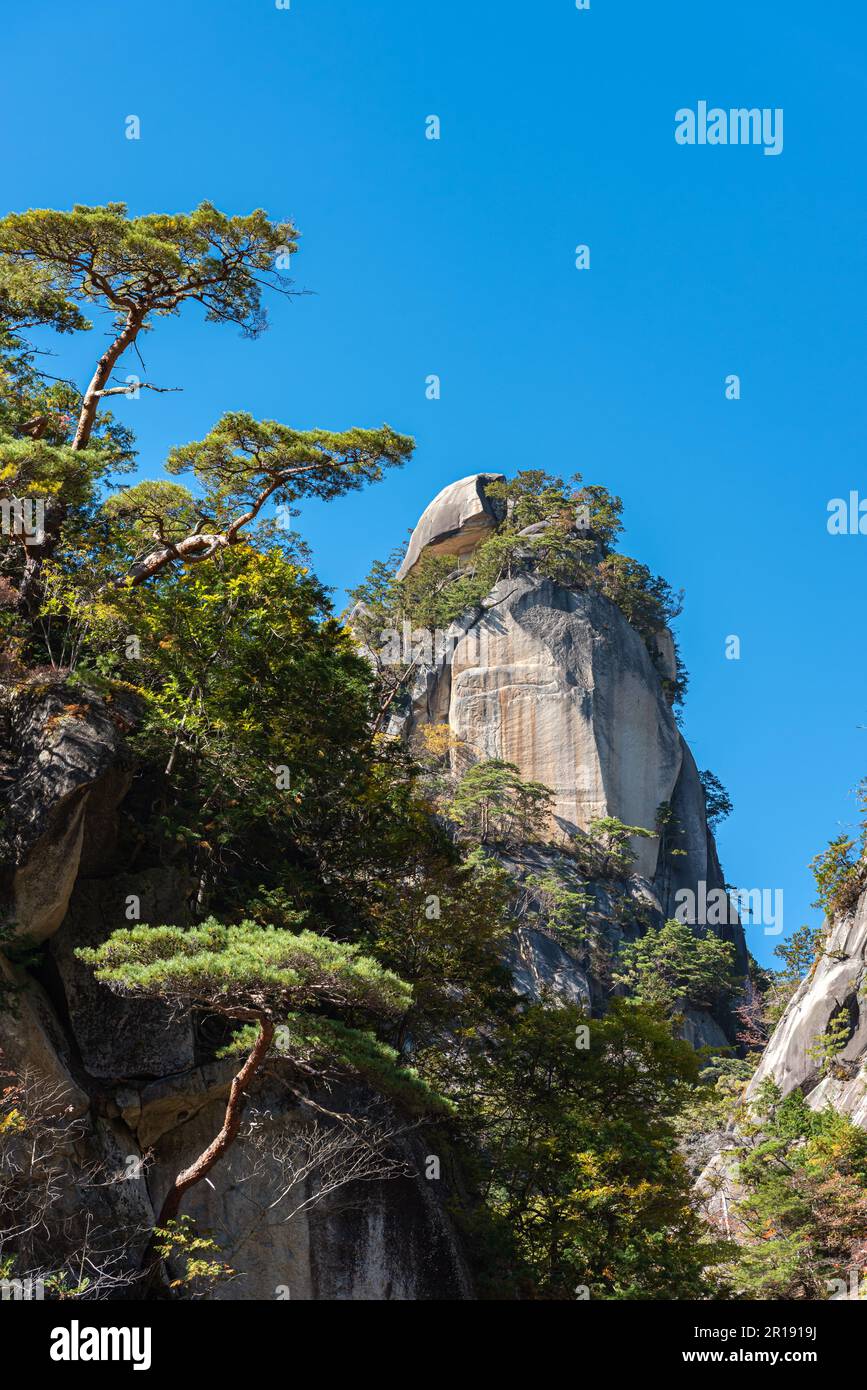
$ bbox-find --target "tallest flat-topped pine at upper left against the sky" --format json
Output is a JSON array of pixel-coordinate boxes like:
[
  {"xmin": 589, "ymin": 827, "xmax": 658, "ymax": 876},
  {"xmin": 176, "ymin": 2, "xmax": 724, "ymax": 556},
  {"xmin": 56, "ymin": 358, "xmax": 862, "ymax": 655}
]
[{"xmin": 0, "ymin": 203, "xmax": 296, "ymax": 612}]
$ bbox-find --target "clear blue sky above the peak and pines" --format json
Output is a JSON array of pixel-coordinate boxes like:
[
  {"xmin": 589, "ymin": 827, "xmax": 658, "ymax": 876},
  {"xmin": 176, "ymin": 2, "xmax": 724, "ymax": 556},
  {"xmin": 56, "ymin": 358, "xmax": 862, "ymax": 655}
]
[{"xmin": 0, "ymin": 0, "xmax": 867, "ymax": 959}]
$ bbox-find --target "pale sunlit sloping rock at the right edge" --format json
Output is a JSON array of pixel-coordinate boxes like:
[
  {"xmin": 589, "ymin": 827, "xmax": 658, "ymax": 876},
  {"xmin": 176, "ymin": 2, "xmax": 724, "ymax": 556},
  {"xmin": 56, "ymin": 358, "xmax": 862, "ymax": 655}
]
[{"xmin": 748, "ymin": 892, "xmax": 867, "ymax": 1129}]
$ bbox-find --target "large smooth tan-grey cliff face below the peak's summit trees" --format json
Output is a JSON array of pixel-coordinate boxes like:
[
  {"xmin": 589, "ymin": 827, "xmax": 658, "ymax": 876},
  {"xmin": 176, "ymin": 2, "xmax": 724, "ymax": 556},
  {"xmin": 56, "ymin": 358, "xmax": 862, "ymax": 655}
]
[{"xmin": 393, "ymin": 575, "xmax": 683, "ymax": 878}]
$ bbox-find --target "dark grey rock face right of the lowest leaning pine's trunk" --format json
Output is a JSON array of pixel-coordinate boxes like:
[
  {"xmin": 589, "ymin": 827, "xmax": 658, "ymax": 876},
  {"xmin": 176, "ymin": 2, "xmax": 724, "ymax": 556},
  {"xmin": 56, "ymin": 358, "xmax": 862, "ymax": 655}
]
[{"xmin": 147, "ymin": 1079, "xmax": 471, "ymax": 1301}]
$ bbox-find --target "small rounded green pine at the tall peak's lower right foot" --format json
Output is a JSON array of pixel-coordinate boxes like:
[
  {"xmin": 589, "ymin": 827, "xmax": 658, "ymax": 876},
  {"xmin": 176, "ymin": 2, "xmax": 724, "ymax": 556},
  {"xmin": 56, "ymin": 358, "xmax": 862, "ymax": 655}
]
[{"xmin": 614, "ymin": 919, "xmax": 735, "ymax": 1015}]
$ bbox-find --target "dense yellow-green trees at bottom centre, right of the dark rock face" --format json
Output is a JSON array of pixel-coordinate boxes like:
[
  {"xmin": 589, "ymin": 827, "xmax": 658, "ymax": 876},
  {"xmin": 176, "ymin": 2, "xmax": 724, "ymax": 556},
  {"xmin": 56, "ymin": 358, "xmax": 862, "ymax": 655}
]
[{"xmin": 439, "ymin": 999, "xmax": 721, "ymax": 1300}]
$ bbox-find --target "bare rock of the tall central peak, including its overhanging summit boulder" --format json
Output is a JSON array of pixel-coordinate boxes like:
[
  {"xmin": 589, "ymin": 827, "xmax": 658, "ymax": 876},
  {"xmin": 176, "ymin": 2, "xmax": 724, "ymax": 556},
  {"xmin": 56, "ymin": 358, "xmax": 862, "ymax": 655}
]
[{"xmin": 389, "ymin": 474, "xmax": 746, "ymax": 1047}]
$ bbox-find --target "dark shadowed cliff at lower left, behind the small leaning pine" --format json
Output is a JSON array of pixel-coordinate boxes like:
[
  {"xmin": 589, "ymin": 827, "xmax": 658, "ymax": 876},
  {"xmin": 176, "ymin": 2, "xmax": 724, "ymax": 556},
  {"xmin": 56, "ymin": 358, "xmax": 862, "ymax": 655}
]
[{"xmin": 0, "ymin": 682, "xmax": 471, "ymax": 1300}]
